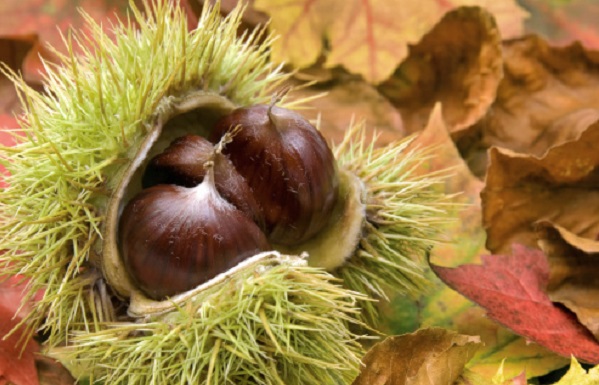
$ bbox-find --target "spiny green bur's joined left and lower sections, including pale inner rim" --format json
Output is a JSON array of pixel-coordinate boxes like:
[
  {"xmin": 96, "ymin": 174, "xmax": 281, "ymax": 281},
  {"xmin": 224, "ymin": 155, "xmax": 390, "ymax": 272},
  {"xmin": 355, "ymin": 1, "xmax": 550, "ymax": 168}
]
[{"xmin": 0, "ymin": 0, "xmax": 366, "ymax": 384}]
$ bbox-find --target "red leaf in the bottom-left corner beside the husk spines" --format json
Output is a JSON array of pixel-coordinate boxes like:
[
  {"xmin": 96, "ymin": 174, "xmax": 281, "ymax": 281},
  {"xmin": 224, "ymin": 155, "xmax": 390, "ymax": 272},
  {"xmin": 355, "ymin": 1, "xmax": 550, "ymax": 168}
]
[{"xmin": 0, "ymin": 277, "xmax": 39, "ymax": 385}]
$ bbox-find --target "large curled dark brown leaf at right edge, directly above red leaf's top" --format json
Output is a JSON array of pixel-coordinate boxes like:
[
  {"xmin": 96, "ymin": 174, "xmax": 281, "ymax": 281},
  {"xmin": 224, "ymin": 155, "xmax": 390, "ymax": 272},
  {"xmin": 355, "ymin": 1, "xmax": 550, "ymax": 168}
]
[{"xmin": 481, "ymin": 121, "xmax": 599, "ymax": 253}]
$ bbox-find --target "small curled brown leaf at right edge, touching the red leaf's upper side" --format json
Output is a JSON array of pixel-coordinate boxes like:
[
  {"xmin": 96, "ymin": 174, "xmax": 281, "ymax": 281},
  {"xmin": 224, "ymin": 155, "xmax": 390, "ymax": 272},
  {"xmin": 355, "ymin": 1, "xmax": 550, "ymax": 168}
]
[{"xmin": 538, "ymin": 222, "xmax": 599, "ymax": 340}]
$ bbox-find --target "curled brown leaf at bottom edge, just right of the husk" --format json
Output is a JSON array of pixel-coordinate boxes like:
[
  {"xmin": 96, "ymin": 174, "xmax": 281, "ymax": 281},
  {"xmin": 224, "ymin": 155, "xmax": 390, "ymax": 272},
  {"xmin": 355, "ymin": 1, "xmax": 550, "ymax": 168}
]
[{"xmin": 353, "ymin": 328, "xmax": 481, "ymax": 385}]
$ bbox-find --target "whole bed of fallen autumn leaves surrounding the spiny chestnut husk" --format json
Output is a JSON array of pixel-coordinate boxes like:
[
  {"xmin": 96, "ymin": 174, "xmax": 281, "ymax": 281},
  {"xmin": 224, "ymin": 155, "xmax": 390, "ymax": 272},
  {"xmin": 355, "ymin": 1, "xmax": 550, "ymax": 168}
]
[{"xmin": 0, "ymin": 0, "xmax": 599, "ymax": 385}]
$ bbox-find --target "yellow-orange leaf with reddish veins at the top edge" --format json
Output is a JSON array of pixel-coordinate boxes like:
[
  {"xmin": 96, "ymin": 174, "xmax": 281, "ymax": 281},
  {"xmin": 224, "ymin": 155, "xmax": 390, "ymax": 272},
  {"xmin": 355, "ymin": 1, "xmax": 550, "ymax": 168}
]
[{"xmin": 254, "ymin": 0, "xmax": 526, "ymax": 83}]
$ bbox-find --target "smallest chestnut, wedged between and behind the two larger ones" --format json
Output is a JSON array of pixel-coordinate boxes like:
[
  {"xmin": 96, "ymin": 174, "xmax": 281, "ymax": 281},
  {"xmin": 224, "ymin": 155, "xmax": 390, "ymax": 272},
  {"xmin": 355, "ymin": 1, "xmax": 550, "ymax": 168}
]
[{"xmin": 142, "ymin": 134, "xmax": 264, "ymax": 228}]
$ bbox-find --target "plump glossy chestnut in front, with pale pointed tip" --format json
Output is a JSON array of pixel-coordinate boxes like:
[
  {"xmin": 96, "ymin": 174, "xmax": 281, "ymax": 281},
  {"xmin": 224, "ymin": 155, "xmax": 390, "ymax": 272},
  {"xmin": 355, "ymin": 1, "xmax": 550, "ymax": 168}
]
[{"xmin": 119, "ymin": 162, "xmax": 271, "ymax": 299}]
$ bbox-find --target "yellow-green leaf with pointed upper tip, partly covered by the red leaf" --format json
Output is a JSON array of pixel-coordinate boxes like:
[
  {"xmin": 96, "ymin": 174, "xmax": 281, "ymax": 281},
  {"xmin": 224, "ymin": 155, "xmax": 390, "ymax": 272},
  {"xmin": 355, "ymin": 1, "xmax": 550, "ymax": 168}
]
[{"xmin": 386, "ymin": 105, "xmax": 567, "ymax": 385}]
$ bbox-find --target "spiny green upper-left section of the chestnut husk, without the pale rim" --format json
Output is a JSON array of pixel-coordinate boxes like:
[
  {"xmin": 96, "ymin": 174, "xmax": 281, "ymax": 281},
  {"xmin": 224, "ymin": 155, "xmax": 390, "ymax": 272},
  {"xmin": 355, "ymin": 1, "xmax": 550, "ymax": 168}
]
[{"xmin": 0, "ymin": 0, "xmax": 285, "ymax": 345}]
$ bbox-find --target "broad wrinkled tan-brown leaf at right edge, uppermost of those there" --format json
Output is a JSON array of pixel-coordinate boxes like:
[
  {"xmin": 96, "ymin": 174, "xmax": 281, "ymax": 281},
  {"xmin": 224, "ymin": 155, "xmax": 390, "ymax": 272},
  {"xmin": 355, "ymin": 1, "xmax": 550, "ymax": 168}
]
[{"xmin": 458, "ymin": 36, "xmax": 599, "ymax": 176}]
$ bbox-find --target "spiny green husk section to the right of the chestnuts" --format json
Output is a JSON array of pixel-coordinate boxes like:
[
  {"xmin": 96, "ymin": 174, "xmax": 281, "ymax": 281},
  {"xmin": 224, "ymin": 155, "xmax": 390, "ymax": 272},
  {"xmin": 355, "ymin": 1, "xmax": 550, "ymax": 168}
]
[{"xmin": 334, "ymin": 124, "xmax": 452, "ymax": 326}]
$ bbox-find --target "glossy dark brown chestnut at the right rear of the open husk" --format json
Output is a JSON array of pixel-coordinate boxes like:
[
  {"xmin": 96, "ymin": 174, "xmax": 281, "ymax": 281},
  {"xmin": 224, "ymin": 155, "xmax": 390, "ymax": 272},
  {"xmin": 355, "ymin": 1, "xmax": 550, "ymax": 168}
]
[{"xmin": 210, "ymin": 105, "xmax": 339, "ymax": 245}]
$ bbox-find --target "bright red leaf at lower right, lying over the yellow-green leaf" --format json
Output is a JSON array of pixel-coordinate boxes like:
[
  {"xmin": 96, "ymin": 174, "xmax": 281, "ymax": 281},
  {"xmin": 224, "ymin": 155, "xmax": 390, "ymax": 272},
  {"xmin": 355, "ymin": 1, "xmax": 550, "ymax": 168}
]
[{"xmin": 431, "ymin": 245, "xmax": 599, "ymax": 364}]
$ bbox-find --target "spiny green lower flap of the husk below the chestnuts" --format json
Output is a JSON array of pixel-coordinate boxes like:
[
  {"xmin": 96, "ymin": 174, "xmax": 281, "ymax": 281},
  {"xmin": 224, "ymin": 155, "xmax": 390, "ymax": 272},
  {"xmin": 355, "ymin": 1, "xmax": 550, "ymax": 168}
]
[{"xmin": 54, "ymin": 253, "xmax": 366, "ymax": 385}]
